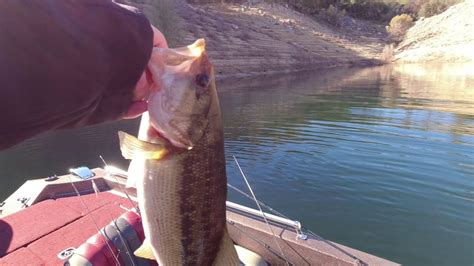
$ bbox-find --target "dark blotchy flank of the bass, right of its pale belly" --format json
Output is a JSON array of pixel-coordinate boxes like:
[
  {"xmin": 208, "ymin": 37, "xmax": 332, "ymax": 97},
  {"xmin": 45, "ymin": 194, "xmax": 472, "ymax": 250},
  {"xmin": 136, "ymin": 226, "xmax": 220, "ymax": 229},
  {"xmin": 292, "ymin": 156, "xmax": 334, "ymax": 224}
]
[{"xmin": 180, "ymin": 125, "xmax": 227, "ymax": 265}]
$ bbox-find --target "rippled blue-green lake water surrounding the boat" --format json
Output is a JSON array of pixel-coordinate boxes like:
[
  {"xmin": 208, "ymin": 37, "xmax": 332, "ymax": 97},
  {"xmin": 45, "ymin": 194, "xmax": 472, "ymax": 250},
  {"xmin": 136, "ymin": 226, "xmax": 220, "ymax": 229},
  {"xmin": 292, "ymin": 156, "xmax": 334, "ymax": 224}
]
[{"xmin": 0, "ymin": 65, "xmax": 474, "ymax": 265}]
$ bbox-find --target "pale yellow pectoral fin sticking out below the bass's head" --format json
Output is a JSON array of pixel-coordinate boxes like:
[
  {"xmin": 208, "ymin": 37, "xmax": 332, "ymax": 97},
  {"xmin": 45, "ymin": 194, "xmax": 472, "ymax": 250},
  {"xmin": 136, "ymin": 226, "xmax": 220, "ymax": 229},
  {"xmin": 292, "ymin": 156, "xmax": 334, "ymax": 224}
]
[{"xmin": 118, "ymin": 131, "xmax": 167, "ymax": 160}]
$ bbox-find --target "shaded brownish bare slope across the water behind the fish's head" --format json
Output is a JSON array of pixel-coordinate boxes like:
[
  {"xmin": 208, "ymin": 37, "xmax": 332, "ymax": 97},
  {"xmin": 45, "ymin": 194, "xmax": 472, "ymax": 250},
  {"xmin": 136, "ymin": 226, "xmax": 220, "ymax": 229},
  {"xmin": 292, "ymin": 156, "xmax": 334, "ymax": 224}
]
[{"xmin": 126, "ymin": 0, "xmax": 386, "ymax": 78}]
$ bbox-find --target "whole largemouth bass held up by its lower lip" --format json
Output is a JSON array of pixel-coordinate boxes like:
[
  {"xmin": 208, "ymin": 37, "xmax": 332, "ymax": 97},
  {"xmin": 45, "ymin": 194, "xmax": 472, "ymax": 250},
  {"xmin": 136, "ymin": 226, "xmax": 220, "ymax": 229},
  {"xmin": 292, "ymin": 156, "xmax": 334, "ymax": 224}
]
[{"xmin": 118, "ymin": 39, "xmax": 239, "ymax": 266}]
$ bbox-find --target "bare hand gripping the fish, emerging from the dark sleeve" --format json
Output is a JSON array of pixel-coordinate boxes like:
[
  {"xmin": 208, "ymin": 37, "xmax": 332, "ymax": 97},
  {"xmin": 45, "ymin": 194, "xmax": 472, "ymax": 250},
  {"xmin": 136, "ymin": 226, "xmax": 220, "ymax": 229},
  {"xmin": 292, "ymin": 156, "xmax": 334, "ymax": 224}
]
[{"xmin": 123, "ymin": 25, "xmax": 168, "ymax": 119}]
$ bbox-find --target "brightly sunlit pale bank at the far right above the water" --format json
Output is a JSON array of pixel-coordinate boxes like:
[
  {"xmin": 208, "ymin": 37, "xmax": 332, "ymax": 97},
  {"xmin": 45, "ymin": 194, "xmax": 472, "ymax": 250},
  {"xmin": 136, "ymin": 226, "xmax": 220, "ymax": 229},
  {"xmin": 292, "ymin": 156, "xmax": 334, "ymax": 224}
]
[{"xmin": 393, "ymin": 0, "xmax": 474, "ymax": 63}]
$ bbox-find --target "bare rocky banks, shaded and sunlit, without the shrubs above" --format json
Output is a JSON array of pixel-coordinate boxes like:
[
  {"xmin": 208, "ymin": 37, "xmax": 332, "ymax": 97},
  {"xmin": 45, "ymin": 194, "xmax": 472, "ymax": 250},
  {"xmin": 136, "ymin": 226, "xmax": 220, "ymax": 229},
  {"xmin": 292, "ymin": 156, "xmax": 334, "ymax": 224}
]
[{"xmin": 126, "ymin": 0, "xmax": 474, "ymax": 79}]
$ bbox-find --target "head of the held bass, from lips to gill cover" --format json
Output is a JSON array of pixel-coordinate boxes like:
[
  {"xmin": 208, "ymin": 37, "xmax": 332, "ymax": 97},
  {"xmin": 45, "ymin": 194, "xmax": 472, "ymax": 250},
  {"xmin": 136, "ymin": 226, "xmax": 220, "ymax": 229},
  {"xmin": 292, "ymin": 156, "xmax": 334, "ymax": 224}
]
[{"xmin": 148, "ymin": 39, "xmax": 213, "ymax": 150}]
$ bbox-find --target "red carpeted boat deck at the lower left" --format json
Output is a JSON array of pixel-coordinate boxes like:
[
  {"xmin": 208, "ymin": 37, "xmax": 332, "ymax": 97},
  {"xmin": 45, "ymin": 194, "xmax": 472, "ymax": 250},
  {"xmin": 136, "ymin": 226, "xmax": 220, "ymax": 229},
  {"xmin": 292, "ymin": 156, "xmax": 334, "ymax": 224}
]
[{"xmin": 0, "ymin": 192, "xmax": 133, "ymax": 265}]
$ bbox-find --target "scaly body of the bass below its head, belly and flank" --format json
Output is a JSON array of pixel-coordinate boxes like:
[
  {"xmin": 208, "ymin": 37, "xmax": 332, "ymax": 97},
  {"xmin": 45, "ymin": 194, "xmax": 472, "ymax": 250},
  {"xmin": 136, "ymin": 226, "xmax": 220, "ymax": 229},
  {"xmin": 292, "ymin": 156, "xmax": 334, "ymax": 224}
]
[{"xmin": 137, "ymin": 130, "xmax": 227, "ymax": 265}]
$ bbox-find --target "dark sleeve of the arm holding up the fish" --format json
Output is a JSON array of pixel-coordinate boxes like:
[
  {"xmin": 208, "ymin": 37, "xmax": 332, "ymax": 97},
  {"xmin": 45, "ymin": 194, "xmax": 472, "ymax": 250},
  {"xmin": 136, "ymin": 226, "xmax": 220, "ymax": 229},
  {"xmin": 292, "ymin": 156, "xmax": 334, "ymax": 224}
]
[{"xmin": 0, "ymin": 0, "xmax": 153, "ymax": 149}]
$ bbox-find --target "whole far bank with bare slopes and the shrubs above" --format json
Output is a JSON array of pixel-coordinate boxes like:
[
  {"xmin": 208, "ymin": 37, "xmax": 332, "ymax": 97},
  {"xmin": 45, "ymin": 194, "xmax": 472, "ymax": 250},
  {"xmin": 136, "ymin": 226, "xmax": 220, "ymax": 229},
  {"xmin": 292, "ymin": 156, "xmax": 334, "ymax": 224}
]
[{"xmin": 122, "ymin": 0, "xmax": 474, "ymax": 79}]
